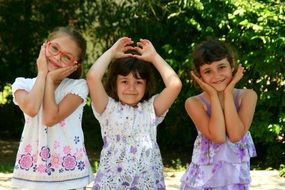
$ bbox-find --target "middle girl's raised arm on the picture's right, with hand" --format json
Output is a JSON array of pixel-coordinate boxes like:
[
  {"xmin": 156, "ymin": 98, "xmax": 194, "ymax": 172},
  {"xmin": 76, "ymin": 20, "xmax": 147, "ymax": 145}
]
[{"xmin": 134, "ymin": 39, "xmax": 182, "ymax": 116}]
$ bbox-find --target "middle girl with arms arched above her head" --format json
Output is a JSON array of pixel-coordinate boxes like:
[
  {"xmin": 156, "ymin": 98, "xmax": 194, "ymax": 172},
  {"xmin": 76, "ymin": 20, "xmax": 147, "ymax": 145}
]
[{"xmin": 87, "ymin": 37, "xmax": 182, "ymax": 189}]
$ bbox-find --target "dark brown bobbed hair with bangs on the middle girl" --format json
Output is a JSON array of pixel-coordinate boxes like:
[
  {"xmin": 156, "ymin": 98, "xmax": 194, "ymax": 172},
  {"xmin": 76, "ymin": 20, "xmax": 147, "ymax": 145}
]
[{"xmin": 105, "ymin": 57, "xmax": 155, "ymax": 102}]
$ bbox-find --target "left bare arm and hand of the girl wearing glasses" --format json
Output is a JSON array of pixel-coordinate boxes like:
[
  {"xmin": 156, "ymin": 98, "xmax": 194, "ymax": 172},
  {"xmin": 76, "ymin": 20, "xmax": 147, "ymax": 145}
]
[{"xmin": 15, "ymin": 44, "xmax": 48, "ymax": 117}]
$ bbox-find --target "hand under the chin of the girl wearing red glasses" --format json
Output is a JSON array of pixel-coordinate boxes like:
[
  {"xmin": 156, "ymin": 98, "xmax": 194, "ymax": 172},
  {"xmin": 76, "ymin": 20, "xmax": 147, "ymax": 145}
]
[{"xmin": 47, "ymin": 64, "xmax": 79, "ymax": 85}]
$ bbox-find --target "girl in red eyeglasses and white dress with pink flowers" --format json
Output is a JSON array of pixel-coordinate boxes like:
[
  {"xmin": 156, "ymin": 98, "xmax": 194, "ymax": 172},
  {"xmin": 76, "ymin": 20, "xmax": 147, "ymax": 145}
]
[{"xmin": 12, "ymin": 27, "xmax": 93, "ymax": 190}]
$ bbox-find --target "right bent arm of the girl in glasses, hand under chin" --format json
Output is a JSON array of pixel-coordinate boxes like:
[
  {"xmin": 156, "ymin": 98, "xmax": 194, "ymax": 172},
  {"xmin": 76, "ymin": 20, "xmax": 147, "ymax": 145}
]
[{"xmin": 43, "ymin": 65, "xmax": 83, "ymax": 127}]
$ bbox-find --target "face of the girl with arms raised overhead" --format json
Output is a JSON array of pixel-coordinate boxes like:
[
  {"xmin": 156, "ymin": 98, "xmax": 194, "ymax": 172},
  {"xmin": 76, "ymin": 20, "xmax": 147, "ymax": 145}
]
[{"xmin": 116, "ymin": 73, "xmax": 146, "ymax": 106}]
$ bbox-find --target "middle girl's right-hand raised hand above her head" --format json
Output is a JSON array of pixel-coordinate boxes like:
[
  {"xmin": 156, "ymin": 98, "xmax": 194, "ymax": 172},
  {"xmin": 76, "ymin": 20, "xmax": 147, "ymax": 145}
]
[{"xmin": 133, "ymin": 39, "xmax": 157, "ymax": 62}]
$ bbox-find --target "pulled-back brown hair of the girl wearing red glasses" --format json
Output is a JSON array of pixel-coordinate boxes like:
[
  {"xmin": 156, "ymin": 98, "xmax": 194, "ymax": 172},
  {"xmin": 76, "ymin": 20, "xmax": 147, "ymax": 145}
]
[{"xmin": 47, "ymin": 26, "xmax": 87, "ymax": 79}]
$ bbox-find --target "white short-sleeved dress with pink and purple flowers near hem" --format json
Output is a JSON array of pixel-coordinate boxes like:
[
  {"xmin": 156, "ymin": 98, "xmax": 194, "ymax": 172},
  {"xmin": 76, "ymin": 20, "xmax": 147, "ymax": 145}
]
[{"xmin": 12, "ymin": 78, "xmax": 93, "ymax": 190}]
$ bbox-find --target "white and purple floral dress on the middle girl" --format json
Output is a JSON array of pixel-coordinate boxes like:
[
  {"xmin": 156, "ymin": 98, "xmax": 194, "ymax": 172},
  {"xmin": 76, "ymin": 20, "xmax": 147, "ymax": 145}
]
[{"xmin": 93, "ymin": 97, "xmax": 166, "ymax": 190}]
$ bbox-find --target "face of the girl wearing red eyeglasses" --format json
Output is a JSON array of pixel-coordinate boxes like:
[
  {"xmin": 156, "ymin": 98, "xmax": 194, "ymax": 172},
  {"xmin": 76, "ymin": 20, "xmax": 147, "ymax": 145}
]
[{"xmin": 46, "ymin": 35, "xmax": 80, "ymax": 71}]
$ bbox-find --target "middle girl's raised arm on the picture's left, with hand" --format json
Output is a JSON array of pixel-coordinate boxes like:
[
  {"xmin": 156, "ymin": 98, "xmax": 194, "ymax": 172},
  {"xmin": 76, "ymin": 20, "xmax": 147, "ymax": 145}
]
[{"xmin": 86, "ymin": 37, "xmax": 133, "ymax": 113}]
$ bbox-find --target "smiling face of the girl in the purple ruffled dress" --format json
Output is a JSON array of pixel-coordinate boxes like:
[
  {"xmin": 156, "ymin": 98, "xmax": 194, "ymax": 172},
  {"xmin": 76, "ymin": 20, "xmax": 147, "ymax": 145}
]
[{"xmin": 200, "ymin": 58, "xmax": 233, "ymax": 91}]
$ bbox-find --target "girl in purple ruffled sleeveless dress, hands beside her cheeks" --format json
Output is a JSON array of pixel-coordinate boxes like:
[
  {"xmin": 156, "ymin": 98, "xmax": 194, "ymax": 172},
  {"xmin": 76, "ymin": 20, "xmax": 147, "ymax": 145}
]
[{"xmin": 181, "ymin": 40, "xmax": 257, "ymax": 190}]
